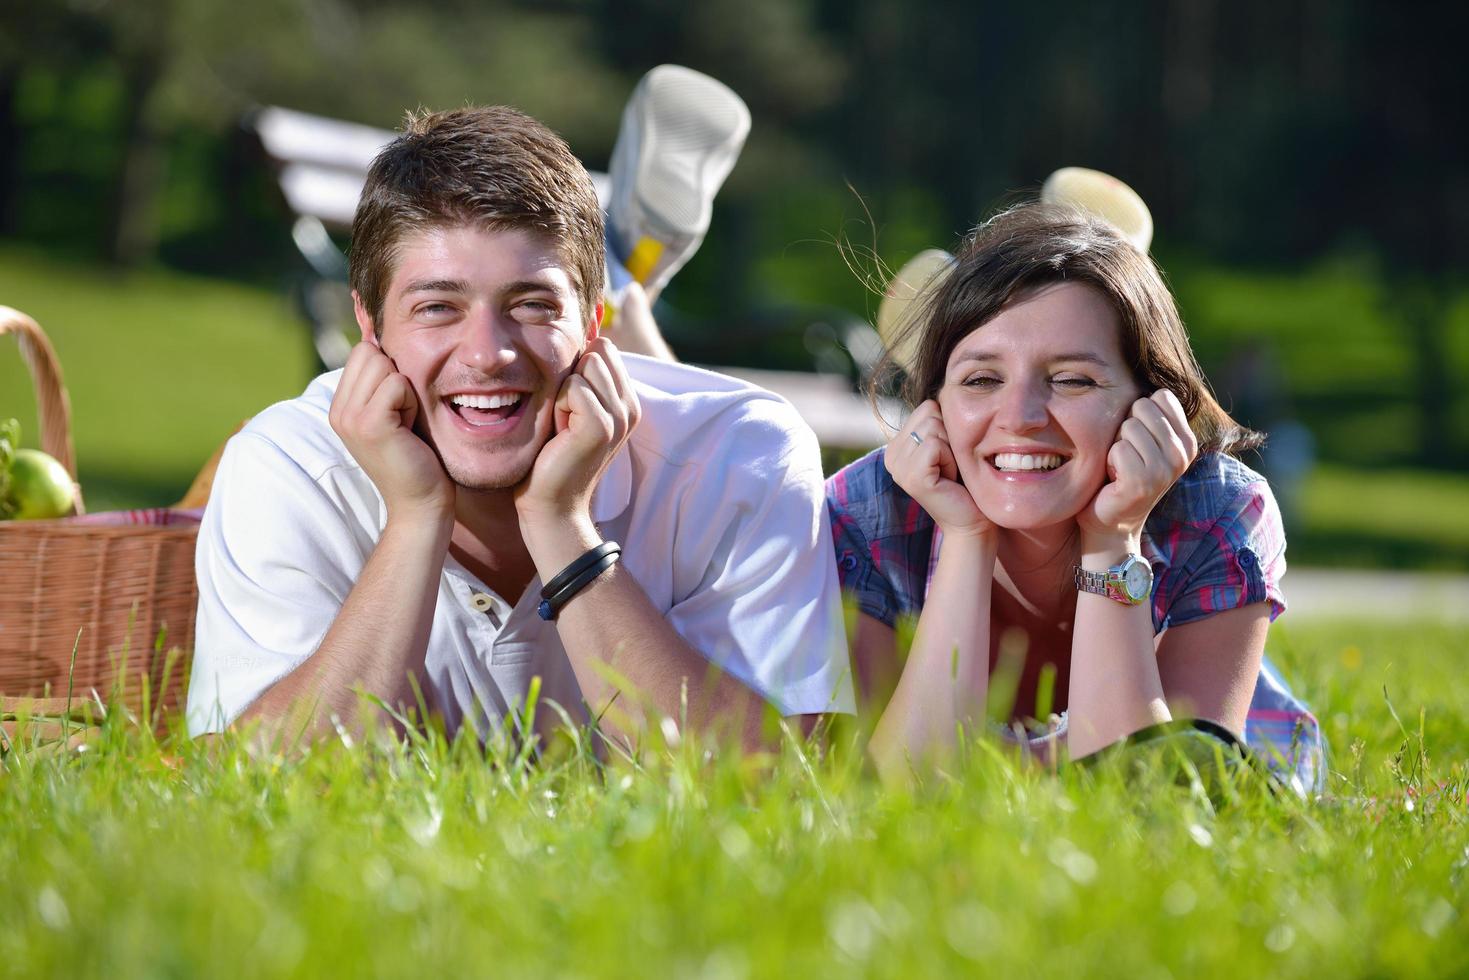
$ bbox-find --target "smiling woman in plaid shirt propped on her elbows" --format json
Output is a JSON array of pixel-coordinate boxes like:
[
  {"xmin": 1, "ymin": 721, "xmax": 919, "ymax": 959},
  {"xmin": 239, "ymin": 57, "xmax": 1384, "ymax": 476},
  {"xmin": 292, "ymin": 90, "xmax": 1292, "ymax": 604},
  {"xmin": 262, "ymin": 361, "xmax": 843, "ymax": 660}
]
[{"xmin": 827, "ymin": 204, "xmax": 1319, "ymax": 788}]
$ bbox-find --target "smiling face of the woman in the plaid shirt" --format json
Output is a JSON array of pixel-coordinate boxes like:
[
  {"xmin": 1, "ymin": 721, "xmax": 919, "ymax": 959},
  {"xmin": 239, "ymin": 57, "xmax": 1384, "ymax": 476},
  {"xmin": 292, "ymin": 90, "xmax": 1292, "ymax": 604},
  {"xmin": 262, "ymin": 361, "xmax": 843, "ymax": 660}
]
[{"xmin": 937, "ymin": 282, "xmax": 1143, "ymax": 530}]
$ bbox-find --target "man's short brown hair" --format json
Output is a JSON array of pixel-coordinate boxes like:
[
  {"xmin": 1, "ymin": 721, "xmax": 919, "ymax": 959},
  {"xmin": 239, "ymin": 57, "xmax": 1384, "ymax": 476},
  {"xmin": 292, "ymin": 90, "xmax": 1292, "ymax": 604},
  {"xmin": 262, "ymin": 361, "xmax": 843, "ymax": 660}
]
[{"xmin": 350, "ymin": 106, "xmax": 605, "ymax": 336}]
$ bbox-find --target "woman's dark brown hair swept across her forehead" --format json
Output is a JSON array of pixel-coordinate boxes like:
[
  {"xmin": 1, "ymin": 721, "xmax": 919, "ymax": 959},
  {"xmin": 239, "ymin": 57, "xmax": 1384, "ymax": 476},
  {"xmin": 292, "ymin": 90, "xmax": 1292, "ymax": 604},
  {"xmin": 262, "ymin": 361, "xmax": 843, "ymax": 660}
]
[{"xmin": 878, "ymin": 204, "xmax": 1263, "ymax": 453}]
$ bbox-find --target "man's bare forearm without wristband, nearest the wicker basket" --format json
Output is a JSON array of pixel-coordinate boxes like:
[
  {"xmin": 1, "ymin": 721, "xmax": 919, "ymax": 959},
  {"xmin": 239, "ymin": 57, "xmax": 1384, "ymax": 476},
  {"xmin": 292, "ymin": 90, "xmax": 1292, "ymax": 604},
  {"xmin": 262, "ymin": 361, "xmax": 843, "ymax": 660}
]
[{"xmin": 235, "ymin": 519, "xmax": 452, "ymax": 741}]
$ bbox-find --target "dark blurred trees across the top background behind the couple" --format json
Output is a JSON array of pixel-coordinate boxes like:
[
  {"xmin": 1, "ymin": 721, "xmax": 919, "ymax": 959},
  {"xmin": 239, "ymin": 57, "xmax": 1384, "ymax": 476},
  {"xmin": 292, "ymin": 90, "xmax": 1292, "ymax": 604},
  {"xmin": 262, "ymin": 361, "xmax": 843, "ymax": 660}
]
[{"xmin": 0, "ymin": 0, "xmax": 1469, "ymax": 464}]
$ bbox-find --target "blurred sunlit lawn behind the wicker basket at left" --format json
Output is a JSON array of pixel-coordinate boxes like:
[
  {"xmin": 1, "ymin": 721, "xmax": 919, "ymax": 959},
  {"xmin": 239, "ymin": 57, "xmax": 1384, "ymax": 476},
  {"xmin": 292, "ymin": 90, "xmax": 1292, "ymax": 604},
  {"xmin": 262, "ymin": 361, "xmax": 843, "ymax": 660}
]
[{"xmin": 0, "ymin": 244, "xmax": 311, "ymax": 510}]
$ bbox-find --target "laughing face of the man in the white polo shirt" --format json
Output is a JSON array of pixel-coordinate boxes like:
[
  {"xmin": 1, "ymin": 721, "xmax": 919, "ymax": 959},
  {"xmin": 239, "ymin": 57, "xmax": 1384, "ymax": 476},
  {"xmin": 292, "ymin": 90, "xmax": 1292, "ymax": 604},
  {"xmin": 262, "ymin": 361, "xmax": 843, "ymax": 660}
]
[{"xmin": 357, "ymin": 225, "xmax": 601, "ymax": 491}]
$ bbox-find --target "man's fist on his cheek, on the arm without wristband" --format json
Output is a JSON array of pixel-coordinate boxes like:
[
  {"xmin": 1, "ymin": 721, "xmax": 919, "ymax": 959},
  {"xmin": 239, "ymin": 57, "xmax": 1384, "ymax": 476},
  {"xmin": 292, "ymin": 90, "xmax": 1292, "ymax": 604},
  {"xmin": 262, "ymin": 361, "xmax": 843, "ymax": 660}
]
[{"xmin": 328, "ymin": 342, "xmax": 454, "ymax": 520}]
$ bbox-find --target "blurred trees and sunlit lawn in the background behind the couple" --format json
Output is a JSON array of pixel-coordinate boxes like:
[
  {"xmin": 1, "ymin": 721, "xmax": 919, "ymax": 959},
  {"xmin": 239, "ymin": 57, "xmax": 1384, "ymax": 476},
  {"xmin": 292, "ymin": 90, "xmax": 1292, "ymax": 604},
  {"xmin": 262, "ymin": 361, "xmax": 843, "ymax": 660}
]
[{"xmin": 0, "ymin": 0, "xmax": 1469, "ymax": 570}]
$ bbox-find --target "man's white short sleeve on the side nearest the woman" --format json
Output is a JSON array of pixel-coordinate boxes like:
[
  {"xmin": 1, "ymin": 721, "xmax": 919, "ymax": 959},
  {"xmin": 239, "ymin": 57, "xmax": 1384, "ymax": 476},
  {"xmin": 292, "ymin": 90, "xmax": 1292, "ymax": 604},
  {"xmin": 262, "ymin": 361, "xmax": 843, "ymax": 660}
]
[{"xmin": 667, "ymin": 403, "xmax": 856, "ymax": 716}]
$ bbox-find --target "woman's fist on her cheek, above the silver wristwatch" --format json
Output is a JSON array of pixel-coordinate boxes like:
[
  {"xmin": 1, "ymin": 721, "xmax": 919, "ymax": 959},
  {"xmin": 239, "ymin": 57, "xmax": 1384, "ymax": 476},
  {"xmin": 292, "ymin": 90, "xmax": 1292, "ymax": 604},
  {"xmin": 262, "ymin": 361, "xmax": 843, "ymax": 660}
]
[{"xmin": 1077, "ymin": 389, "xmax": 1199, "ymax": 541}]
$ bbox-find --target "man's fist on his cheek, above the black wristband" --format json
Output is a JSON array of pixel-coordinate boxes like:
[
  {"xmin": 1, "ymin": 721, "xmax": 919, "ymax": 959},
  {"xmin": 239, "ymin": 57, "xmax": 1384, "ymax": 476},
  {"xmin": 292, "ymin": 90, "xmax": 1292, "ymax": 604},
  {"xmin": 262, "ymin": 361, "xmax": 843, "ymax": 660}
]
[{"xmin": 516, "ymin": 336, "xmax": 642, "ymax": 543}]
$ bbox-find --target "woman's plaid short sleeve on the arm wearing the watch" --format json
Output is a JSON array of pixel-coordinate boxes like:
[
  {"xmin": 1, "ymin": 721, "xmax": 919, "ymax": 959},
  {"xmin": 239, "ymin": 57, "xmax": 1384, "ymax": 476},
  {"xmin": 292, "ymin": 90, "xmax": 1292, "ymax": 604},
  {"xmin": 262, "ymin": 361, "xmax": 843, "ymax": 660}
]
[{"xmin": 1155, "ymin": 479, "xmax": 1285, "ymax": 629}]
